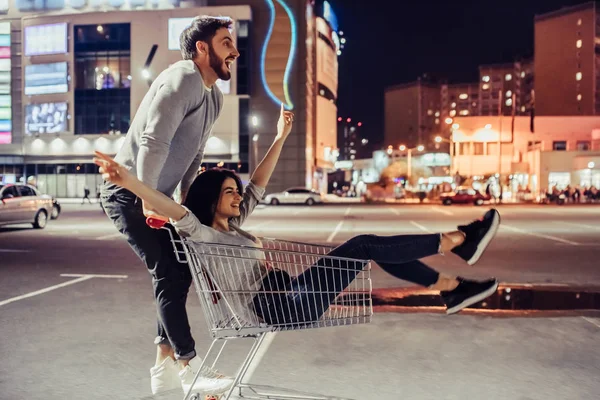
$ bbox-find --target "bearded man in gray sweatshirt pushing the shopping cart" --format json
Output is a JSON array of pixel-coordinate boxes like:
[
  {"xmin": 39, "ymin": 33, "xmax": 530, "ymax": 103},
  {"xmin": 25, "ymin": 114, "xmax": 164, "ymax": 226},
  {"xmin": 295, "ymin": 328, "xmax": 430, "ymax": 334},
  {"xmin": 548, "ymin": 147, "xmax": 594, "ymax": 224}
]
[{"xmin": 101, "ymin": 16, "xmax": 239, "ymax": 394}]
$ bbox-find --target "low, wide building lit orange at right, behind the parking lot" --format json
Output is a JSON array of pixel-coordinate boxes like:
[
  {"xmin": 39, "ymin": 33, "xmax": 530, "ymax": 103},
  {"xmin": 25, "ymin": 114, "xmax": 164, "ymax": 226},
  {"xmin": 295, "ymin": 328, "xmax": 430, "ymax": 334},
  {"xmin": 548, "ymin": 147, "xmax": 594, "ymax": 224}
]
[{"xmin": 452, "ymin": 116, "xmax": 600, "ymax": 194}]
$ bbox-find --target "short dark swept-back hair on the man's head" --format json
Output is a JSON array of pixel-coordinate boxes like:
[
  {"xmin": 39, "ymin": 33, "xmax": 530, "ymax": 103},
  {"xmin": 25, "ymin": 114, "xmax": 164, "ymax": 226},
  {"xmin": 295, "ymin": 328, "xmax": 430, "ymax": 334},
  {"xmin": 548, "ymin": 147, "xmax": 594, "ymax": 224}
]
[{"xmin": 179, "ymin": 15, "xmax": 233, "ymax": 60}]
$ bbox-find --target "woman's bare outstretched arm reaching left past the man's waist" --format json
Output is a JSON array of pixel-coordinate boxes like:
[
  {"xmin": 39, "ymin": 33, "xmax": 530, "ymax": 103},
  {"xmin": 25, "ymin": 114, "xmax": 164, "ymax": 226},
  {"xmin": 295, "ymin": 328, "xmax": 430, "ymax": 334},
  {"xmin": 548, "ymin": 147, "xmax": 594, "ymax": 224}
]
[{"xmin": 94, "ymin": 151, "xmax": 187, "ymax": 221}]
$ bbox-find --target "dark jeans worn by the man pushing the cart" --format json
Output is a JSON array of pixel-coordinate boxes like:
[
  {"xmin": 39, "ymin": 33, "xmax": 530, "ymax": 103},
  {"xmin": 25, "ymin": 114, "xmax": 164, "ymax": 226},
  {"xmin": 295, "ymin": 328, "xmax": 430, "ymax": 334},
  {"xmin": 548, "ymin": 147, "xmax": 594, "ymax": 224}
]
[{"xmin": 100, "ymin": 184, "xmax": 196, "ymax": 359}]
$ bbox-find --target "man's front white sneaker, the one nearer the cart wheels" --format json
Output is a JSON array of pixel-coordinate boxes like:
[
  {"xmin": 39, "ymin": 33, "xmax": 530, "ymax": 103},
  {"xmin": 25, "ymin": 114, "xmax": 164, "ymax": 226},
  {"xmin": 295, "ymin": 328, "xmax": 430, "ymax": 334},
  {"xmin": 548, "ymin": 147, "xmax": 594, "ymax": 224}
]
[{"xmin": 179, "ymin": 357, "xmax": 233, "ymax": 395}]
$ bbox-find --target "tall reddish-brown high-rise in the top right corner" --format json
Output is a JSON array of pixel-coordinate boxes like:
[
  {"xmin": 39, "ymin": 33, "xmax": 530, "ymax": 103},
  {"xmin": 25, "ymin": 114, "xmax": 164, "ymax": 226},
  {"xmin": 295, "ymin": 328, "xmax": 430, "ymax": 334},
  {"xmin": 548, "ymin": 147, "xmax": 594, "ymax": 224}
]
[{"xmin": 535, "ymin": 2, "xmax": 600, "ymax": 115}]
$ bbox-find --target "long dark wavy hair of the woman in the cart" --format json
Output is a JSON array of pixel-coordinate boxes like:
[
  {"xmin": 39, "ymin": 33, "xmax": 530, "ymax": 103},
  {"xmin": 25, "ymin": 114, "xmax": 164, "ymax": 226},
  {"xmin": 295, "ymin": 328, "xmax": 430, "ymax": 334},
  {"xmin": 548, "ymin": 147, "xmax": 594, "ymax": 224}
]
[{"xmin": 183, "ymin": 168, "xmax": 244, "ymax": 226}]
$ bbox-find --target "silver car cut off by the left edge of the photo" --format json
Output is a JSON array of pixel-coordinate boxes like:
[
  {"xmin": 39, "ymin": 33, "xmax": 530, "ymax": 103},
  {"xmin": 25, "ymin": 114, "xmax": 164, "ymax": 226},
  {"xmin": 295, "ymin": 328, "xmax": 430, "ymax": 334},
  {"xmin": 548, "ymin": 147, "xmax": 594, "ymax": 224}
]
[{"xmin": 0, "ymin": 184, "xmax": 53, "ymax": 229}]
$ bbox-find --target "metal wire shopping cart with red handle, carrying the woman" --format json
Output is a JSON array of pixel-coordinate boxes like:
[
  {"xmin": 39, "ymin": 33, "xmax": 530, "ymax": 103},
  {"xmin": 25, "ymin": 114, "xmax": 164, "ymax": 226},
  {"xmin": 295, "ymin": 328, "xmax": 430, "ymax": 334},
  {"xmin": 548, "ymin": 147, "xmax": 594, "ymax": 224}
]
[{"xmin": 157, "ymin": 223, "xmax": 373, "ymax": 400}]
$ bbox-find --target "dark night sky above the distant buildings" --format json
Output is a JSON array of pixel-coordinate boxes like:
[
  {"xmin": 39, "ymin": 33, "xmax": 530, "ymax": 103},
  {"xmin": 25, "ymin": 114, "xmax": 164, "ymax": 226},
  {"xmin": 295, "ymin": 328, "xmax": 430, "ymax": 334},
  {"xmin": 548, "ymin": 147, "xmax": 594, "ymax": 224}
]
[{"xmin": 329, "ymin": 0, "xmax": 587, "ymax": 147}]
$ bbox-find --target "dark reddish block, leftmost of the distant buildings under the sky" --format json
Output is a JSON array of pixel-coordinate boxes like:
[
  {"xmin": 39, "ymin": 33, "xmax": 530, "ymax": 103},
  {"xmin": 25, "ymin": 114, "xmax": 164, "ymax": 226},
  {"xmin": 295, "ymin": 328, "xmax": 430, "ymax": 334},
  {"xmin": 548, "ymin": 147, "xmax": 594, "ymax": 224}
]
[{"xmin": 384, "ymin": 79, "xmax": 441, "ymax": 147}]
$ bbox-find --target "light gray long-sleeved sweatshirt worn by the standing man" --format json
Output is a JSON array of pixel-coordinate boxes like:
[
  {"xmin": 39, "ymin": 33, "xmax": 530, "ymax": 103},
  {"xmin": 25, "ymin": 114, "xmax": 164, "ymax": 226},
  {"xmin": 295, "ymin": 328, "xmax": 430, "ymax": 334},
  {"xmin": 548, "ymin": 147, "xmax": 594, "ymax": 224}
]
[{"xmin": 115, "ymin": 60, "xmax": 223, "ymax": 196}]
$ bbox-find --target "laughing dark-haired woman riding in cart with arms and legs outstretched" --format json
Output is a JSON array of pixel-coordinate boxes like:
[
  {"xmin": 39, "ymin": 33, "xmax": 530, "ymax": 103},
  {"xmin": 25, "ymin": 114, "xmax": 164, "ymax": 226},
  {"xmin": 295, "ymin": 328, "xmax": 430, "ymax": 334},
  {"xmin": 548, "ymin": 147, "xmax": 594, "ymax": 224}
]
[{"xmin": 94, "ymin": 106, "xmax": 500, "ymax": 324}]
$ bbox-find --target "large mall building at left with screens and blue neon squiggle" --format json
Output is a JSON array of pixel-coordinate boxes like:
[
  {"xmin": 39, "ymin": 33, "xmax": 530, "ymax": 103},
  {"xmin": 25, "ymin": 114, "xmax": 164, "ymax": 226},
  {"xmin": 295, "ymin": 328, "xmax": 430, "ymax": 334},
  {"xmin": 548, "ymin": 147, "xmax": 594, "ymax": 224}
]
[{"xmin": 0, "ymin": 0, "xmax": 339, "ymax": 197}]
